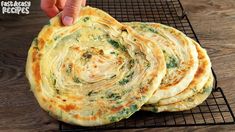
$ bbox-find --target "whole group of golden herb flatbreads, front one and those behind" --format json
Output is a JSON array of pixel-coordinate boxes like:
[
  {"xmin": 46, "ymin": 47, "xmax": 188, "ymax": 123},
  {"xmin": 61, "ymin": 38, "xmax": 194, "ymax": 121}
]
[{"xmin": 26, "ymin": 7, "xmax": 213, "ymax": 126}]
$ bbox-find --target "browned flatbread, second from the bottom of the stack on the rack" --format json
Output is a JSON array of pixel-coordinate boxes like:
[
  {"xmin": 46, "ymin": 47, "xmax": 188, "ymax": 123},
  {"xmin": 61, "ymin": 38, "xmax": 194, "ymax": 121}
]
[{"xmin": 158, "ymin": 39, "xmax": 211, "ymax": 106}]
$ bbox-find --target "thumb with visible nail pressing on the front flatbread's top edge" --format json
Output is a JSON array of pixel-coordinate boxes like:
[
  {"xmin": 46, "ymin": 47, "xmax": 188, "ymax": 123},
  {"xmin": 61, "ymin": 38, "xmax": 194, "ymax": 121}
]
[{"xmin": 62, "ymin": 0, "xmax": 83, "ymax": 26}]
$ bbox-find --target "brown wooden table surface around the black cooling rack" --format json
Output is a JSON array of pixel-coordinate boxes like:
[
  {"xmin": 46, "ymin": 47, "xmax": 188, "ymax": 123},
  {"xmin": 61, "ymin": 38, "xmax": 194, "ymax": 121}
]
[{"xmin": 0, "ymin": 0, "xmax": 235, "ymax": 132}]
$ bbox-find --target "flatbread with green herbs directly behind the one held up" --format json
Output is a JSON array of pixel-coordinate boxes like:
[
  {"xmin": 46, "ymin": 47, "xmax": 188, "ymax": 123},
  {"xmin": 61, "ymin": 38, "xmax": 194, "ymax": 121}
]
[{"xmin": 125, "ymin": 22, "xmax": 198, "ymax": 104}]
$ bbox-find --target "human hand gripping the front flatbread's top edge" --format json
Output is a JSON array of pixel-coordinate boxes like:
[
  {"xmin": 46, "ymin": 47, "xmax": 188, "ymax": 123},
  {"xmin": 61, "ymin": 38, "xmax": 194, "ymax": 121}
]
[{"xmin": 41, "ymin": 0, "xmax": 86, "ymax": 26}]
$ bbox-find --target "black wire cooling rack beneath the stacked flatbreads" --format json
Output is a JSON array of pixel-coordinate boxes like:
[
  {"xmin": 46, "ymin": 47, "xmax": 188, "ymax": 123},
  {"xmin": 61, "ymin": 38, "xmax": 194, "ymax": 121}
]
[{"xmin": 59, "ymin": 0, "xmax": 235, "ymax": 132}]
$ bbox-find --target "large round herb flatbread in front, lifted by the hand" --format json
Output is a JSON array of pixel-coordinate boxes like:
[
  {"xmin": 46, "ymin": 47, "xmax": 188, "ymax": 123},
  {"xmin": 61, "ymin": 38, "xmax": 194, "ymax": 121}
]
[{"xmin": 26, "ymin": 7, "xmax": 166, "ymax": 126}]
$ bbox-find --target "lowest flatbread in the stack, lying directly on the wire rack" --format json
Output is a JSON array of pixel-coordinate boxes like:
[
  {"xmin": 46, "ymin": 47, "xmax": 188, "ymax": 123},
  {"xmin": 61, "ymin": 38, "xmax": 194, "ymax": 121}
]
[{"xmin": 142, "ymin": 73, "xmax": 214, "ymax": 113}]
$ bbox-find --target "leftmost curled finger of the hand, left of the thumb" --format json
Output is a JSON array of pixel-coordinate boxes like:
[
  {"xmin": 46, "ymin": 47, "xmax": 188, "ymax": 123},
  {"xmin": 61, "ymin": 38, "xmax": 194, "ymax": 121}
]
[{"xmin": 41, "ymin": 0, "xmax": 59, "ymax": 17}]
